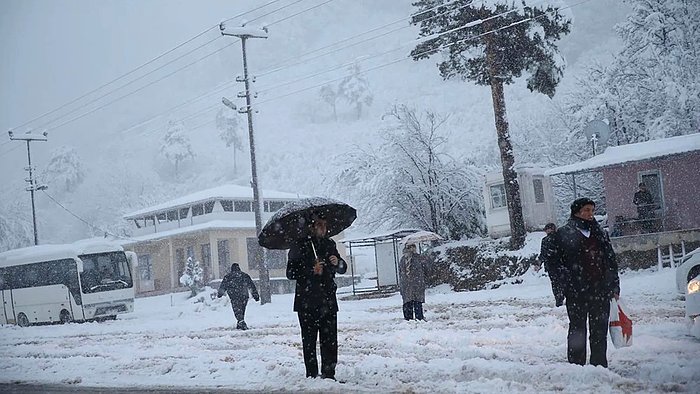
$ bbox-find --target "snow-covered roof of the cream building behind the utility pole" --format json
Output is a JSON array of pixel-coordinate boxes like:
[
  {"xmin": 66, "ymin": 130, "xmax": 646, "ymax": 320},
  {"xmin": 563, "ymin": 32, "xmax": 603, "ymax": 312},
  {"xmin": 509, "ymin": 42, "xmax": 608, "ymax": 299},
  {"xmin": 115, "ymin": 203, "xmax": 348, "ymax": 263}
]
[{"xmin": 124, "ymin": 184, "xmax": 306, "ymax": 219}]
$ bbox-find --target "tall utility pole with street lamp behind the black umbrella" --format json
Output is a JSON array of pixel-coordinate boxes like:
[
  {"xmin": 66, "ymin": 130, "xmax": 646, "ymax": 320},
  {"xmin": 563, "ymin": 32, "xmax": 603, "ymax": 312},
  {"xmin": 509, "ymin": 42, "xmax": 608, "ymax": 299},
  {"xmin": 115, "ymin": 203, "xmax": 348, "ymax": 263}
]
[{"xmin": 219, "ymin": 23, "xmax": 272, "ymax": 305}]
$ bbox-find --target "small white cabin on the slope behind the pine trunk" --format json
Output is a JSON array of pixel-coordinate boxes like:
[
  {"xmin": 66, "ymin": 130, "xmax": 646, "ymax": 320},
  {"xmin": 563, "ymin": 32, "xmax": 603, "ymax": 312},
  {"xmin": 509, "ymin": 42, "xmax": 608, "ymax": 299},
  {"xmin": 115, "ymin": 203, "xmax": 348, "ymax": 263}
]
[{"xmin": 483, "ymin": 164, "xmax": 556, "ymax": 238}]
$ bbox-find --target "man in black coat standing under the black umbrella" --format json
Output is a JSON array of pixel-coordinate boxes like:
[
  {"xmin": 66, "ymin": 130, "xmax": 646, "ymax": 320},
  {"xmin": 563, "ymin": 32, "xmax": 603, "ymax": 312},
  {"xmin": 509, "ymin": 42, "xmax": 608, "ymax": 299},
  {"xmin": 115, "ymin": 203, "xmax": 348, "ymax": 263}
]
[{"xmin": 287, "ymin": 214, "xmax": 347, "ymax": 380}]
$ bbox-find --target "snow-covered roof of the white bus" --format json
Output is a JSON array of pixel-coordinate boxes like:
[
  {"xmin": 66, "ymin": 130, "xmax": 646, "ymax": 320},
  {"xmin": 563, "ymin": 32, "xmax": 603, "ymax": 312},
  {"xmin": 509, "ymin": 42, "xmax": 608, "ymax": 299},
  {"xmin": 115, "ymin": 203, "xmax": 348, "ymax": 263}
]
[{"xmin": 0, "ymin": 238, "xmax": 123, "ymax": 267}]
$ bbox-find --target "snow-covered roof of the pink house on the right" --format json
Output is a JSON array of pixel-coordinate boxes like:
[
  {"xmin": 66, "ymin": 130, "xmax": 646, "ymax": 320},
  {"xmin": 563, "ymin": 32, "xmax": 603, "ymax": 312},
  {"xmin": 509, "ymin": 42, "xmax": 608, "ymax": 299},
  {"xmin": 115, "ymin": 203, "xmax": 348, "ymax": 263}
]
[{"xmin": 545, "ymin": 133, "xmax": 700, "ymax": 175}]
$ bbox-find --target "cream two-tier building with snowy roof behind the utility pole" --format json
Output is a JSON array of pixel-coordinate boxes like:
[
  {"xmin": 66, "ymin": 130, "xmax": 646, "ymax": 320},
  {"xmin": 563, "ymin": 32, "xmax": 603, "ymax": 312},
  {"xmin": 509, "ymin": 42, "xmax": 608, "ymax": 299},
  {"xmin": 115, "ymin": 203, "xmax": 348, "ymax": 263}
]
[{"xmin": 124, "ymin": 185, "xmax": 305, "ymax": 293}]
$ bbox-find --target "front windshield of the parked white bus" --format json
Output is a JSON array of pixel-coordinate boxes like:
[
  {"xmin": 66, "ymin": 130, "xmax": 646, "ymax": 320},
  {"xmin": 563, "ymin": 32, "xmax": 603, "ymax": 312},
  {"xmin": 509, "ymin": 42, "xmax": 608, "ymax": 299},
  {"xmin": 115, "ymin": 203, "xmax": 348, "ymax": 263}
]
[{"xmin": 79, "ymin": 252, "xmax": 133, "ymax": 293}]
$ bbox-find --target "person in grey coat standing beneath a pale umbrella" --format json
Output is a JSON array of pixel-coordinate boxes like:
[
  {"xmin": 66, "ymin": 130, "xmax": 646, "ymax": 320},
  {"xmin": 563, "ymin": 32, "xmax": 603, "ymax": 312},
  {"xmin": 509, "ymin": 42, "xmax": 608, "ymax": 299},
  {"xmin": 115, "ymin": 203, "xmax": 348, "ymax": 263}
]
[{"xmin": 399, "ymin": 244, "xmax": 427, "ymax": 320}]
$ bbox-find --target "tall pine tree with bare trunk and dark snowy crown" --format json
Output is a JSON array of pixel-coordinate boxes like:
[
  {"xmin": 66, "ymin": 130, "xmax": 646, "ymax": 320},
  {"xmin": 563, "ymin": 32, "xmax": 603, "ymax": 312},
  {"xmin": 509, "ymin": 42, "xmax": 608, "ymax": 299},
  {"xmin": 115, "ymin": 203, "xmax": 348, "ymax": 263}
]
[{"xmin": 411, "ymin": 0, "xmax": 571, "ymax": 249}]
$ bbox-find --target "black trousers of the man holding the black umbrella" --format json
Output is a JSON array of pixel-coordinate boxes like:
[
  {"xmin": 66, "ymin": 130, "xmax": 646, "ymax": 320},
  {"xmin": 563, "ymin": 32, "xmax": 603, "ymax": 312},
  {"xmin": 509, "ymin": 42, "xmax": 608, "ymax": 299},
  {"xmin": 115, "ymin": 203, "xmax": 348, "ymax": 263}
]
[{"xmin": 298, "ymin": 311, "xmax": 338, "ymax": 378}]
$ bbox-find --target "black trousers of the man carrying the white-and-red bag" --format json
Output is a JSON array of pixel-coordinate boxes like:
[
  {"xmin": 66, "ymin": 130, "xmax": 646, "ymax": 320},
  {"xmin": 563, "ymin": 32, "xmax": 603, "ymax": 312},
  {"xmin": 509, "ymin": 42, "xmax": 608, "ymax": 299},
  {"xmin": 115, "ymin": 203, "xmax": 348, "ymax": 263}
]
[{"xmin": 566, "ymin": 293, "xmax": 610, "ymax": 368}]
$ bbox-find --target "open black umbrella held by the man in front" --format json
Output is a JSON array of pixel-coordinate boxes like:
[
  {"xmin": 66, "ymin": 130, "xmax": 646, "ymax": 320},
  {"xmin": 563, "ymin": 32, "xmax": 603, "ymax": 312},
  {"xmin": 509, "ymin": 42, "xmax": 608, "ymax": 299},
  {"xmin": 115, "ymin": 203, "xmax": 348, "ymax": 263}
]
[{"xmin": 258, "ymin": 197, "xmax": 357, "ymax": 249}]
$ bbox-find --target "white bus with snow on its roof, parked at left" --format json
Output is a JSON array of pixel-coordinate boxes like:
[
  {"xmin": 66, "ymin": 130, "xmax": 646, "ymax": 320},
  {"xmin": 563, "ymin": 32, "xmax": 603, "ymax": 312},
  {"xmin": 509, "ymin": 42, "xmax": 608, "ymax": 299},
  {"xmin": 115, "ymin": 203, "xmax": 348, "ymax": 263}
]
[{"xmin": 0, "ymin": 239, "xmax": 138, "ymax": 327}]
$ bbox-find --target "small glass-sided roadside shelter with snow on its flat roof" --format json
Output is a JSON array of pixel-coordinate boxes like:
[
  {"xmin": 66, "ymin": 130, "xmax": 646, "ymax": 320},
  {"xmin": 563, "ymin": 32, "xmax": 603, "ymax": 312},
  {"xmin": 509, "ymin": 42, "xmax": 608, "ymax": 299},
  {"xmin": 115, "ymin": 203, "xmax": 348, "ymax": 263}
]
[{"xmin": 340, "ymin": 228, "xmax": 421, "ymax": 295}]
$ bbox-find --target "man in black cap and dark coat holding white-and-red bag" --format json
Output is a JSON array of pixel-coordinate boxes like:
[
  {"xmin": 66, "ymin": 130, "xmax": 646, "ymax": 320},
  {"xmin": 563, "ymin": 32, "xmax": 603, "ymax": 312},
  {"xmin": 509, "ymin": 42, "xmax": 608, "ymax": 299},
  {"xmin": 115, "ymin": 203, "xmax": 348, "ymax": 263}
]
[{"xmin": 550, "ymin": 198, "xmax": 620, "ymax": 368}]
